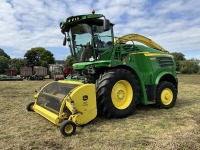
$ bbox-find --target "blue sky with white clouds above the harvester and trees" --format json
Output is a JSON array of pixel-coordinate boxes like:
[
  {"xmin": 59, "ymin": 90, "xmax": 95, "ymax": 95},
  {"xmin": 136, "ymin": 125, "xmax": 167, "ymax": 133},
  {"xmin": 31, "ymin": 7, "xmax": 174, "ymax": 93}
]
[{"xmin": 0, "ymin": 0, "xmax": 200, "ymax": 60}]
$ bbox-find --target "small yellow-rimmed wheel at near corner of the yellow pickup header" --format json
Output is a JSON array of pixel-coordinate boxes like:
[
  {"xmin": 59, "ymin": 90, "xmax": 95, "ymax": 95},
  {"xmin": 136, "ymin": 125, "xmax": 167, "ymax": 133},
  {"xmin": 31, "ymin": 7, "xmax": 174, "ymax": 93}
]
[{"xmin": 60, "ymin": 120, "xmax": 76, "ymax": 136}]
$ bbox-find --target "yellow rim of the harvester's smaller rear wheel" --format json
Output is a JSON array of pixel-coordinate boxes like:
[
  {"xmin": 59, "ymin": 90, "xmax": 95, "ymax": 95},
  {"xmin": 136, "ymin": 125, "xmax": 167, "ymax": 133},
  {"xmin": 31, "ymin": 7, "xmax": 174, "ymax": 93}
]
[{"xmin": 161, "ymin": 88, "xmax": 173, "ymax": 105}]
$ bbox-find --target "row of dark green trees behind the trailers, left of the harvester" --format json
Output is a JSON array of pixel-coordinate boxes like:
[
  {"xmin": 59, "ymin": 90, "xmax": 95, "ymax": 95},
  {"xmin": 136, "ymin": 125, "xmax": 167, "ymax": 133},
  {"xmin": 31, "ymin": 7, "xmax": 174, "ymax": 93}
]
[{"xmin": 0, "ymin": 47, "xmax": 72, "ymax": 74}]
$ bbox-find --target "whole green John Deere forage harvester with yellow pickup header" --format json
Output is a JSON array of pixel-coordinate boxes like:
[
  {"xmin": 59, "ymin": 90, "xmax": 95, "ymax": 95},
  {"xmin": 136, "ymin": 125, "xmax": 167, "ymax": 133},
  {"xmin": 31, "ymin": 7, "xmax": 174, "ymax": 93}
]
[{"xmin": 27, "ymin": 13, "xmax": 178, "ymax": 136}]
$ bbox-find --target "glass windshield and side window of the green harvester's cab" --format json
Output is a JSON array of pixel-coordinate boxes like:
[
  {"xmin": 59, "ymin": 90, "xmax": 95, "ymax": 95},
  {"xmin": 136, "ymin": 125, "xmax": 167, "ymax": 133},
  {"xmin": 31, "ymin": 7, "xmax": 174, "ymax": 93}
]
[{"xmin": 69, "ymin": 24, "xmax": 113, "ymax": 62}]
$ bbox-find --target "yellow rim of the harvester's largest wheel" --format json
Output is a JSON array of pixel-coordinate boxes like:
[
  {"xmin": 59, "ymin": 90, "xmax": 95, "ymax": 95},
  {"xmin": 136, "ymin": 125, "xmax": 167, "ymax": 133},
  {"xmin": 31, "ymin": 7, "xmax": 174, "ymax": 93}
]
[{"xmin": 111, "ymin": 80, "xmax": 133, "ymax": 109}]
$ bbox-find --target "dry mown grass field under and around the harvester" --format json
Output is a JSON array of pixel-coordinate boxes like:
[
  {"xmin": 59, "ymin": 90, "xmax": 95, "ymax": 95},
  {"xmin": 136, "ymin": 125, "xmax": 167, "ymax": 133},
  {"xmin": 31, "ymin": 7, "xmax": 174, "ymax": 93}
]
[{"xmin": 0, "ymin": 75, "xmax": 200, "ymax": 150}]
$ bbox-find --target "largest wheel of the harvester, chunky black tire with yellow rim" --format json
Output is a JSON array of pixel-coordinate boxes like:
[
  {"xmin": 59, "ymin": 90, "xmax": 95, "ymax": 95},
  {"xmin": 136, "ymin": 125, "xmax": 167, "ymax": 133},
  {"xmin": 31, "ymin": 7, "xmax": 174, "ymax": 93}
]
[{"xmin": 96, "ymin": 68, "xmax": 140, "ymax": 118}]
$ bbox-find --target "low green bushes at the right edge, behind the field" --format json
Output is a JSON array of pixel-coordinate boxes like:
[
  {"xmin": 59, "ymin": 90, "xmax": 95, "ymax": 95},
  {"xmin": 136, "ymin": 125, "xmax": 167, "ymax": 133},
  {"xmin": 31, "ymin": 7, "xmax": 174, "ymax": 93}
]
[{"xmin": 180, "ymin": 59, "xmax": 199, "ymax": 74}]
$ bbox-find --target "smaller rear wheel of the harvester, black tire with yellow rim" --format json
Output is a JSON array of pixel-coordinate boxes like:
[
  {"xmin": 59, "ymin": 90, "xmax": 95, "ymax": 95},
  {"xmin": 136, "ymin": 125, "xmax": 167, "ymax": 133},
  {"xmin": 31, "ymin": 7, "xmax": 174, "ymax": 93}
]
[{"xmin": 156, "ymin": 81, "xmax": 177, "ymax": 109}]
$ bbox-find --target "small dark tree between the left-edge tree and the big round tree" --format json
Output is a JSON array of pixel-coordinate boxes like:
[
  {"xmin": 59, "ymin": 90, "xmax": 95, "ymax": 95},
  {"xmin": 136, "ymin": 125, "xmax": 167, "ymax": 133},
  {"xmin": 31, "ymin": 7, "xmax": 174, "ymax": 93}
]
[{"xmin": 10, "ymin": 58, "xmax": 25, "ymax": 74}]
